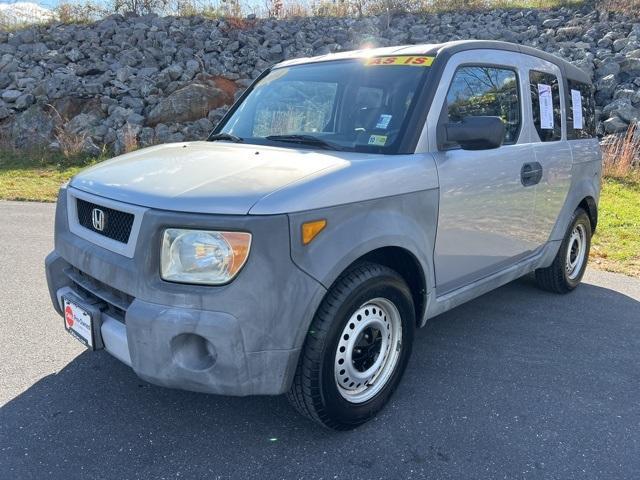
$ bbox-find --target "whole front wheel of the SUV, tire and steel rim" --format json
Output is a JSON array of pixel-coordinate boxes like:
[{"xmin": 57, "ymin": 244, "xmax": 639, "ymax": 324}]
[{"xmin": 289, "ymin": 263, "xmax": 415, "ymax": 430}]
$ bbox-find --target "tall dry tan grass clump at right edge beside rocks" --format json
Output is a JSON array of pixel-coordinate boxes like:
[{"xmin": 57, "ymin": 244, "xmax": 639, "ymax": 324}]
[{"xmin": 602, "ymin": 124, "xmax": 640, "ymax": 179}]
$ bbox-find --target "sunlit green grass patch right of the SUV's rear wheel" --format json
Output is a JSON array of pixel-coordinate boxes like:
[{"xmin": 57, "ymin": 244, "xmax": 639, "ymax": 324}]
[{"xmin": 591, "ymin": 173, "xmax": 640, "ymax": 277}]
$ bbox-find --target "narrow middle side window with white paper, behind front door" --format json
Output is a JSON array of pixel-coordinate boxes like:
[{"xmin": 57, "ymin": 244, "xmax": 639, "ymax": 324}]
[{"xmin": 529, "ymin": 70, "xmax": 562, "ymax": 142}]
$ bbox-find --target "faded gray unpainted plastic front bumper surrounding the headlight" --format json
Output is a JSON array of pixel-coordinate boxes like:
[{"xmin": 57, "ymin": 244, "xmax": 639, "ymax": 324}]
[{"xmin": 45, "ymin": 191, "xmax": 326, "ymax": 395}]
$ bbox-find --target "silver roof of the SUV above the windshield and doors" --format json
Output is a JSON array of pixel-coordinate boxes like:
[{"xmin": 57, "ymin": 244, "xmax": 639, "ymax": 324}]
[{"xmin": 276, "ymin": 40, "xmax": 591, "ymax": 84}]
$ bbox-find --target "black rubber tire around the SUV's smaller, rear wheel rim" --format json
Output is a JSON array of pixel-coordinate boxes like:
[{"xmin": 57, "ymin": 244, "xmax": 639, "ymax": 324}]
[{"xmin": 535, "ymin": 208, "xmax": 591, "ymax": 293}]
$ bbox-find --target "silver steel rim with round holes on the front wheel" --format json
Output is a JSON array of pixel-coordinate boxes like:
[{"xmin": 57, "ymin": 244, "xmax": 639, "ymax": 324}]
[{"xmin": 334, "ymin": 298, "xmax": 402, "ymax": 403}]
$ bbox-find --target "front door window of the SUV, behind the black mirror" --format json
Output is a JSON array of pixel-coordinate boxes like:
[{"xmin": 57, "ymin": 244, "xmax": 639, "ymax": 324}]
[{"xmin": 446, "ymin": 65, "xmax": 521, "ymax": 146}]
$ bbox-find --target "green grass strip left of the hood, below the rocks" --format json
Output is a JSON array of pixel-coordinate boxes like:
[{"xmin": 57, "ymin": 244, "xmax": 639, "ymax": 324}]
[{"xmin": 0, "ymin": 150, "xmax": 102, "ymax": 202}]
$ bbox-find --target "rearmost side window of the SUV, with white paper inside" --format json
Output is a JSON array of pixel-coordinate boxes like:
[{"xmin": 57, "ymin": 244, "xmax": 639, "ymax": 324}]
[{"xmin": 566, "ymin": 79, "xmax": 596, "ymax": 140}]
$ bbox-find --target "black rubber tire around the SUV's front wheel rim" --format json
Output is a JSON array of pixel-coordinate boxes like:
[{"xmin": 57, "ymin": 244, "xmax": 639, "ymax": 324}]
[{"xmin": 288, "ymin": 262, "xmax": 416, "ymax": 430}]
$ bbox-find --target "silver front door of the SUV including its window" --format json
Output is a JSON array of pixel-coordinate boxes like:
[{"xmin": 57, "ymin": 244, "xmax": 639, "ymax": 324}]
[{"xmin": 434, "ymin": 51, "xmax": 540, "ymax": 296}]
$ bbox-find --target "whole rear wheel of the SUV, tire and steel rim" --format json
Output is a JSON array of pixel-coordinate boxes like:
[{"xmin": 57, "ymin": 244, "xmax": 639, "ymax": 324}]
[{"xmin": 536, "ymin": 208, "xmax": 591, "ymax": 293}]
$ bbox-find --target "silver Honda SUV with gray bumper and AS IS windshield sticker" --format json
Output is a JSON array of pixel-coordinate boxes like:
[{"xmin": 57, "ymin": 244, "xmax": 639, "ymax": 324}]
[{"xmin": 46, "ymin": 41, "xmax": 601, "ymax": 429}]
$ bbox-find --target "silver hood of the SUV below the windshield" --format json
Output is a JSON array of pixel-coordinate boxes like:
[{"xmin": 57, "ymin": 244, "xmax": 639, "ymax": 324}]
[{"xmin": 70, "ymin": 142, "xmax": 347, "ymax": 214}]
